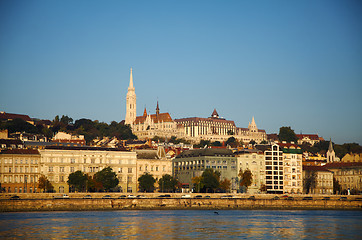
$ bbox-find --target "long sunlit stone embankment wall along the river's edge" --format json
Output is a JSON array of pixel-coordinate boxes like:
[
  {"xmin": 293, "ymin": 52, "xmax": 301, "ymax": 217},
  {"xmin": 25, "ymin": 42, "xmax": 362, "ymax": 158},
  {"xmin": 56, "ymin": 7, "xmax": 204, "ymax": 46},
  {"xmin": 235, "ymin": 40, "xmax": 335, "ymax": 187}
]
[{"xmin": 0, "ymin": 194, "xmax": 362, "ymax": 212}]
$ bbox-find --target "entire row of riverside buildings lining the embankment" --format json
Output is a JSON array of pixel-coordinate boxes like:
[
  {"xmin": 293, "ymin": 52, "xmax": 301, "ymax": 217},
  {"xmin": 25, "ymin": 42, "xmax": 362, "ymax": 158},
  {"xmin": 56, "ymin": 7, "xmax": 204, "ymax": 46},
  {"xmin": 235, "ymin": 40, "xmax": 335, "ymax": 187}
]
[{"xmin": 0, "ymin": 133, "xmax": 362, "ymax": 194}]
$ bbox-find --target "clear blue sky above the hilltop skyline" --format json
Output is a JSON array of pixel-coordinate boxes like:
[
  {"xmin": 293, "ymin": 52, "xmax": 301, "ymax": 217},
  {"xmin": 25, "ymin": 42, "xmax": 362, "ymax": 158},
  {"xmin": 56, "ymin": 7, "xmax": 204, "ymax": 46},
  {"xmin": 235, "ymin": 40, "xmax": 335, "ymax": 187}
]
[{"xmin": 0, "ymin": 0, "xmax": 362, "ymax": 144}]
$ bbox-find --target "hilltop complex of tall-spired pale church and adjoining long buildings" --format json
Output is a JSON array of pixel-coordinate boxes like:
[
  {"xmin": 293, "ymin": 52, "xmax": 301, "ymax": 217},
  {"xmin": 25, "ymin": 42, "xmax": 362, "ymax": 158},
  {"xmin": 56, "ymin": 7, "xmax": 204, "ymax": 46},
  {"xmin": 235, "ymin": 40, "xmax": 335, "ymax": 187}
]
[{"xmin": 125, "ymin": 68, "xmax": 267, "ymax": 143}]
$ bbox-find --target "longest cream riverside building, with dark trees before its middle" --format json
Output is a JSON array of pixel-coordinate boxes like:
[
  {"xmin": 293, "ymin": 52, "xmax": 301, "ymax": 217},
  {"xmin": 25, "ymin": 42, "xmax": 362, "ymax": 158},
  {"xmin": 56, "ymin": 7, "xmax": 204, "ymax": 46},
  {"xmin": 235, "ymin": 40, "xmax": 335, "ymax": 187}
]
[{"xmin": 39, "ymin": 146, "xmax": 137, "ymax": 193}]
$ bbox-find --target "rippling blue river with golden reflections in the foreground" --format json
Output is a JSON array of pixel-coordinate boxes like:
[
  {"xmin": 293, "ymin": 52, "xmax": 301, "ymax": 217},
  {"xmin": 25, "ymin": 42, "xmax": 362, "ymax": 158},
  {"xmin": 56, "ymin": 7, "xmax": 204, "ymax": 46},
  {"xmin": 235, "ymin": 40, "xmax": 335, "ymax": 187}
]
[{"xmin": 0, "ymin": 210, "xmax": 362, "ymax": 240}]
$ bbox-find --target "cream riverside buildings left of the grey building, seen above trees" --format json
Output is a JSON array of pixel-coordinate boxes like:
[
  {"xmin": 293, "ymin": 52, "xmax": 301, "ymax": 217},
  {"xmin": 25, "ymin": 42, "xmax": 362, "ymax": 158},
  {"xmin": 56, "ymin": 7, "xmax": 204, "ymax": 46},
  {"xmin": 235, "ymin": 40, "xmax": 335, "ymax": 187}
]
[{"xmin": 0, "ymin": 140, "xmax": 172, "ymax": 193}]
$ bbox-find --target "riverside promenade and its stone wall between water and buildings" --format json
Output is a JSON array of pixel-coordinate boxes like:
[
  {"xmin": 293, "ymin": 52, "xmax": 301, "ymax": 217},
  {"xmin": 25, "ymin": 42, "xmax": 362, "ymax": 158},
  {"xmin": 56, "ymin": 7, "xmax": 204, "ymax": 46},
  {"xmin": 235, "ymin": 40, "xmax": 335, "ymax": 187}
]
[{"xmin": 0, "ymin": 193, "xmax": 362, "ymax": 212}]
